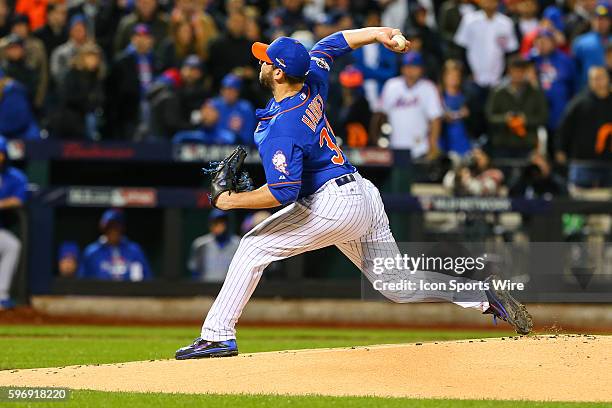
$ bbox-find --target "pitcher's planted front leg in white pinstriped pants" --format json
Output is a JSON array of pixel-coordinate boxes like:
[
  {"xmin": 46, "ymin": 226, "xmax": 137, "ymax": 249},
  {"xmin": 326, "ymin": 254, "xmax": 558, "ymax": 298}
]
[{"xmin": 202, "ymin": 180, "xmax": 370, "ymax": 341}]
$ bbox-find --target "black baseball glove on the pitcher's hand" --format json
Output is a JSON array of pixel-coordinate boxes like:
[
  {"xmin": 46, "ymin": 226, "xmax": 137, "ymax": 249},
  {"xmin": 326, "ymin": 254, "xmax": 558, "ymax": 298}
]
[{"xmin": 202, "ymin": 146, "xmax": 254, "ymax": 207}]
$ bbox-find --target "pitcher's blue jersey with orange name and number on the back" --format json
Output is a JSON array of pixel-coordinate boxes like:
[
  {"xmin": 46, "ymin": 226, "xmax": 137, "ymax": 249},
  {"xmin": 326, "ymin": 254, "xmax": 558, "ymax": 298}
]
[{"xmin": 255, "ymin": 33, "xmax": 356, "ymax": 204}]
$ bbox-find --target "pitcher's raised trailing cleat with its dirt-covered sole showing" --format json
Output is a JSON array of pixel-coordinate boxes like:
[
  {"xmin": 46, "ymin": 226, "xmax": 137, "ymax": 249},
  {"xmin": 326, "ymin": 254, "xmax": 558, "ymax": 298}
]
[{"xmin": 484, "ymin": 275, "xmax": 533, "ymax": 334}]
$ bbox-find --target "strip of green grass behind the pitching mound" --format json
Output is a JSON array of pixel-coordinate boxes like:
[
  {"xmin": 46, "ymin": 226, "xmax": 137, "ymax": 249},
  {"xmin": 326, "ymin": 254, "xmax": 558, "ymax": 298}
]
[{"xmin": 0, "ymin": 326, "xmax": 510, "ymax": 370}]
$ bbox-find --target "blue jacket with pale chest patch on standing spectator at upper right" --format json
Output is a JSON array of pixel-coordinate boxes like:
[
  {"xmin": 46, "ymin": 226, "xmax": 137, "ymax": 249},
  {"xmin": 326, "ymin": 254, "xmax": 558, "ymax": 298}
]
[{"xmin": 531, "ymin": 50, "xmax": 576, "ymax": 129}]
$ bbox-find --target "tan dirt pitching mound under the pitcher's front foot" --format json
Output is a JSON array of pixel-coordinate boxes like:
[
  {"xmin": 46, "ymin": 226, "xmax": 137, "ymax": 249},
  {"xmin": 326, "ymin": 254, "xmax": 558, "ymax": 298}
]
[{"xmin": 0, "ymin": 335, "xmax": 612, "ymax": 401}]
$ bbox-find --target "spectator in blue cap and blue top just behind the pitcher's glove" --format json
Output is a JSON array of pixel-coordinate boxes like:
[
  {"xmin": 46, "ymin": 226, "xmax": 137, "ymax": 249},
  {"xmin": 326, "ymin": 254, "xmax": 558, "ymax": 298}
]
[{"xmin": 211, "ymin": 74, "xmax": 255, "ymax": 145}]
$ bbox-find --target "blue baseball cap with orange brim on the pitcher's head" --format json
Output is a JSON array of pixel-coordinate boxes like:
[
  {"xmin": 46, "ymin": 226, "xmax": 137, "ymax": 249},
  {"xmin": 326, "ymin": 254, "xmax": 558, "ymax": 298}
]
[{"xmin": 251, "ymin": 37, "xmax": 310, "ymax": 78}]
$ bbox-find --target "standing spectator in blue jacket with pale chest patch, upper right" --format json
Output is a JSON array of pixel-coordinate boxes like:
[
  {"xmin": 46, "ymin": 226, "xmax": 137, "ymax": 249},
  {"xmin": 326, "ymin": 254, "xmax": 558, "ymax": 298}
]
[{"xmin": 530, "ymin": 29, "xmax": 576, "ymax": 135}]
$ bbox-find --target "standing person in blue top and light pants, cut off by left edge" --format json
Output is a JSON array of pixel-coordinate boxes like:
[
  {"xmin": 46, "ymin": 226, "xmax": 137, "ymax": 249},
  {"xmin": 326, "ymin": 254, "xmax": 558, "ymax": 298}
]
[{"xmin": 0, "ymin": 135, "xmax": 28, "ymax": 310}]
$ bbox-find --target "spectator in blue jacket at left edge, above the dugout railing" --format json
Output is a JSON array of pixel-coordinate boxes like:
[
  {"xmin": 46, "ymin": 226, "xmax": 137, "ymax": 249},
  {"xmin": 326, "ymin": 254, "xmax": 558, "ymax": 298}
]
[{"xmin": 0, "ymin": 69, "xmax": 40, "ymax": 139}]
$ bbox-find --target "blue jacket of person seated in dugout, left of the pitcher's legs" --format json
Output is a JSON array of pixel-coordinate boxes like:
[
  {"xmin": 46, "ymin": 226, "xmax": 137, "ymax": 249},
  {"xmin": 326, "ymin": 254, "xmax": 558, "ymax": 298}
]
[{"xmin": 77, "ymin": 237, "xmax": 151, "ymax": 281}]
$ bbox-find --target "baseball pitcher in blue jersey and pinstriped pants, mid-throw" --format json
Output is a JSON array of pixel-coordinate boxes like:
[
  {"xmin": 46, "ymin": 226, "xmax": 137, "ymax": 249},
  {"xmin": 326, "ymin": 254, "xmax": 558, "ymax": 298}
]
[{"xmin": 176, "ymin": 27, "xmax": 532, "ymax": 359}]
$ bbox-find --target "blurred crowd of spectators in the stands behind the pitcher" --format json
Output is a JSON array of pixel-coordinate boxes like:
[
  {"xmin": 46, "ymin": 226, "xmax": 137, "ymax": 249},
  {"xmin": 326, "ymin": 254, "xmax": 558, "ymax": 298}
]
[{"xmin": 0, "ymin": 0, "xmax": 612, "ymax": 180}]
